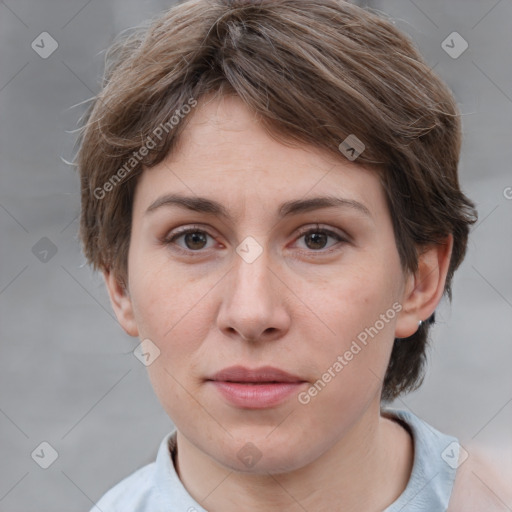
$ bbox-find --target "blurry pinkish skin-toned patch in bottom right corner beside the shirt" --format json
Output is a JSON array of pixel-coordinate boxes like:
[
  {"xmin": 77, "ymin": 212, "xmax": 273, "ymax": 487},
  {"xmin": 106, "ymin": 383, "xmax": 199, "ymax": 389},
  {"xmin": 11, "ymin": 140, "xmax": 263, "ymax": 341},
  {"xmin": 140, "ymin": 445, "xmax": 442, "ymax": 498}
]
[{"xmin": 447, "ymin": 451, "xmax": 512, "ymax": 512}]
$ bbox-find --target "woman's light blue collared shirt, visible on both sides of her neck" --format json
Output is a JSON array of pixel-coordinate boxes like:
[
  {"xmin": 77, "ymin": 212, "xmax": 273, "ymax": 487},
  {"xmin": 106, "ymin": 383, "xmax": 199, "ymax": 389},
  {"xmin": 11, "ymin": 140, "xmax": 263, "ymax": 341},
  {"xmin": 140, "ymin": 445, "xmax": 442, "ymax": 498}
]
[{"xmin": 90, "ymin": 409, "xmax": 459, "ymax": 512}]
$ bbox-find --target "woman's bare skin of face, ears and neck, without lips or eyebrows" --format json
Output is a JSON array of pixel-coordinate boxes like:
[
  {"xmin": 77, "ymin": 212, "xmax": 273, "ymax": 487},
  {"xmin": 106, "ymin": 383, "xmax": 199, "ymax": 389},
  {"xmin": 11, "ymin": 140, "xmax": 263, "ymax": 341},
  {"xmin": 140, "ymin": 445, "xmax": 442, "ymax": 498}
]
[{"xmin": 104, "ymin": 96, "xmax": 453, "ymax": 512}]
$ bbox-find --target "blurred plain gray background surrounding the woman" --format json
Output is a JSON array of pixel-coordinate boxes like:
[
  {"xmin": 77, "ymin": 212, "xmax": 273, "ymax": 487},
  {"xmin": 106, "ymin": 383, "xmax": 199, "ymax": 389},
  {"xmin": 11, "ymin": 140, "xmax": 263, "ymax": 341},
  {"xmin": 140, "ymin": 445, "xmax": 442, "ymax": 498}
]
[{"xmin": 0, "ymin": 0, "xmax": 512, "ymax": 512}]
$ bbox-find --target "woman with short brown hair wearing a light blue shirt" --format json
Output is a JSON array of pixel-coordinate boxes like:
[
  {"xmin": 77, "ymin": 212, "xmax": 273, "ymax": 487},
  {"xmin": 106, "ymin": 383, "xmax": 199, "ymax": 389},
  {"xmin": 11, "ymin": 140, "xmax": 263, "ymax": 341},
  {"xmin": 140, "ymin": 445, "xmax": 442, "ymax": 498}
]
[{"xmin": 77, "ymin": 0, "xmax": 506, "ymax": 512}]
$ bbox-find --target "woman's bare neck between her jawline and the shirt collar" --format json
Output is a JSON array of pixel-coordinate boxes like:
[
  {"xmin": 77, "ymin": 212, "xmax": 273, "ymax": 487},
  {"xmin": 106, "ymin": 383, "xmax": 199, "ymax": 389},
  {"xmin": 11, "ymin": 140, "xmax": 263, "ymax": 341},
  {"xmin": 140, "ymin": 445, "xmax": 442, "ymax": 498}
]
[{"xmin": 176, "ymin": 403, "xmax": 413, "ymax": 512}]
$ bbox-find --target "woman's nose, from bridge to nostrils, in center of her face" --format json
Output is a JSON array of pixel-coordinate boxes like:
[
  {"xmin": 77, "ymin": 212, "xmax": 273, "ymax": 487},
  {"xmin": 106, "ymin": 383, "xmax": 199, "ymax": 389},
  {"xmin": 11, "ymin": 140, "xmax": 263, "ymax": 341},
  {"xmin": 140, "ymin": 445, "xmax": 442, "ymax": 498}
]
[{"xmin": 217, "ymin": 245, "xmax": 291, "ymax": 342}]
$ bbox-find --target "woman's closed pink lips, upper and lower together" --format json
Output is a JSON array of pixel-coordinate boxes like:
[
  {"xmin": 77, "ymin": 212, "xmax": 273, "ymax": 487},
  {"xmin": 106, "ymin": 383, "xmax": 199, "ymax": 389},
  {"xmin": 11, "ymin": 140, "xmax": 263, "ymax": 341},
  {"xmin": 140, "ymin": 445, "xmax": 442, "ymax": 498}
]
[{"xmin": 207, "ymin": 366, "xmax": 307, "ymax": 409}]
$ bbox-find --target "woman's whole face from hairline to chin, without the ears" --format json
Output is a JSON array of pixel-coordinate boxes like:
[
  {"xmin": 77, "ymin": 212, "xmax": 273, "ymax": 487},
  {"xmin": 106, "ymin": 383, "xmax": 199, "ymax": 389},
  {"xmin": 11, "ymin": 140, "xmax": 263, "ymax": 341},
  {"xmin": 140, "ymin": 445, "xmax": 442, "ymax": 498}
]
[{"xmin": 111, "ymin": 97, "xmax": 416, "ymax": 471}]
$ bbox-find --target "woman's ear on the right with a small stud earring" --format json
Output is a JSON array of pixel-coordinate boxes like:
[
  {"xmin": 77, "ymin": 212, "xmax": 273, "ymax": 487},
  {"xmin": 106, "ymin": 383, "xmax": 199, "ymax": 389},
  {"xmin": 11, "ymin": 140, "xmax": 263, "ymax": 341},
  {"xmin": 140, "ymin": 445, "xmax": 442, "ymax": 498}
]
[{"xmin": 395, "ymin": 234, "xmax": 453, "ymax": 338}]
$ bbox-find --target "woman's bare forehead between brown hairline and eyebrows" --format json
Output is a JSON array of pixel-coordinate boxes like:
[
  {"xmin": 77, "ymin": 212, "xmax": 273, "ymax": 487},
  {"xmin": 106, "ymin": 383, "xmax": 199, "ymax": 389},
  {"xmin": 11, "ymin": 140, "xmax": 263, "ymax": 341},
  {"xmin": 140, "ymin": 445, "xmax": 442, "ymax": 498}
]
[{"xmin": 136, "ymin": 96, "xmax": 385, "ymax": 222}]
